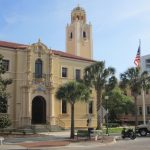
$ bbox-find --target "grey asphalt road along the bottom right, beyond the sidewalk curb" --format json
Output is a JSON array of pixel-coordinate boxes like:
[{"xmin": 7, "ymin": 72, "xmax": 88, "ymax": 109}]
[{"xmin": 44, "ymin": 137, "xmax": 150, "ymax": 150}]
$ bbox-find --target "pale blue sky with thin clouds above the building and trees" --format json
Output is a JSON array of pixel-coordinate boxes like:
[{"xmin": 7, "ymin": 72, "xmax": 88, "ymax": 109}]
[{"xmin": 0, "ymin": 0, "xmax": 150, "ymax": 76}]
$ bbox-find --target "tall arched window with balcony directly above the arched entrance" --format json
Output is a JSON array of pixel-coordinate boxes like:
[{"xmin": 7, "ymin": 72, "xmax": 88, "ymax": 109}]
[{"xmin": 35, "ymin": 59, "xmax": 42, "ymax": 78}]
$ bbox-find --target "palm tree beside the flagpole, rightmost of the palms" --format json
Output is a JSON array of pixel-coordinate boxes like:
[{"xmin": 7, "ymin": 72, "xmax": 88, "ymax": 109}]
[{"xmin": 120, "ymin": 67, "xmax": 150, "ymax": 126}]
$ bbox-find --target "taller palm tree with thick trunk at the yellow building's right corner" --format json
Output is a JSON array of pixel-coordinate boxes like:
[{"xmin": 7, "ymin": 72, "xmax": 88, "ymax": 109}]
[{"xmin": 84, "ymin": 61, "xmax": 117, "ymax": 129}]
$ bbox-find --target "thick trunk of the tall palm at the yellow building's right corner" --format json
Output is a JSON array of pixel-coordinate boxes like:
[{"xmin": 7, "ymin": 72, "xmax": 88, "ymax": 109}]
[{"xmin": 96, "ymin": 90, "xmax": 103, "ymax": 130}]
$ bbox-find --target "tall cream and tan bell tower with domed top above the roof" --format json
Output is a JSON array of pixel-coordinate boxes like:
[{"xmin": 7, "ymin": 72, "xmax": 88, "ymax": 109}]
[{"xmin": 66, "ymin": 6, "xmax": 93, "ymax": 59}]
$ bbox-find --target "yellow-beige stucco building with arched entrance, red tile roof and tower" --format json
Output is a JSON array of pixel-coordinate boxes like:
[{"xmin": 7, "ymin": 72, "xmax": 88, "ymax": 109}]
[{"xmin": 0, "ymin": 6, "xmax": 96, "ymax": 128}]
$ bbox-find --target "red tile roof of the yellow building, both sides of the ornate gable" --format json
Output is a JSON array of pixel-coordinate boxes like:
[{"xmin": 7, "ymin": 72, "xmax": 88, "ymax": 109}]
[{"xmin": 0, "ymin": 41, "xmax": 94, "ymax": 62}]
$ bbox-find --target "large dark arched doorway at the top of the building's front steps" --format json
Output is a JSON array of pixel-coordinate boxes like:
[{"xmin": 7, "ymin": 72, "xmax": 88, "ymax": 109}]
[{"xmin": 31, "ymin": 96, "xmax": 46, "ymax": 124}]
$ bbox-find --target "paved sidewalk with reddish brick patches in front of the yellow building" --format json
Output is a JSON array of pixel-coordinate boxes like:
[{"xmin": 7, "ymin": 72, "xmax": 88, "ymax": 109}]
[{"xmin": 0, "ymin": 131, "xmax": 114, "ymax": 150}]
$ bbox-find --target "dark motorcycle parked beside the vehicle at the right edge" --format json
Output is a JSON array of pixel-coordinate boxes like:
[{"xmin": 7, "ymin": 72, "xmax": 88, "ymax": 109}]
[{"xmin": 121, "ymin": 128, "xmax": 136, "ymax": 140}]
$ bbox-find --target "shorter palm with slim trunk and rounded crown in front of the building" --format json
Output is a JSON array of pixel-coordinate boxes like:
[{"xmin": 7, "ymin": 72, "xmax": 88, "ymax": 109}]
[{"xmin": 56, "ymin": 81, "xmax": 90, "ymax": 139}]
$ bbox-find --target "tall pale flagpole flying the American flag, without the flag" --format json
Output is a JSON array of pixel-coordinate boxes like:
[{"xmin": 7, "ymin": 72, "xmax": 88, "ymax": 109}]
[{"xmin": 139, "ymin": 39, "xmax": 146, "ymax": 124}]
